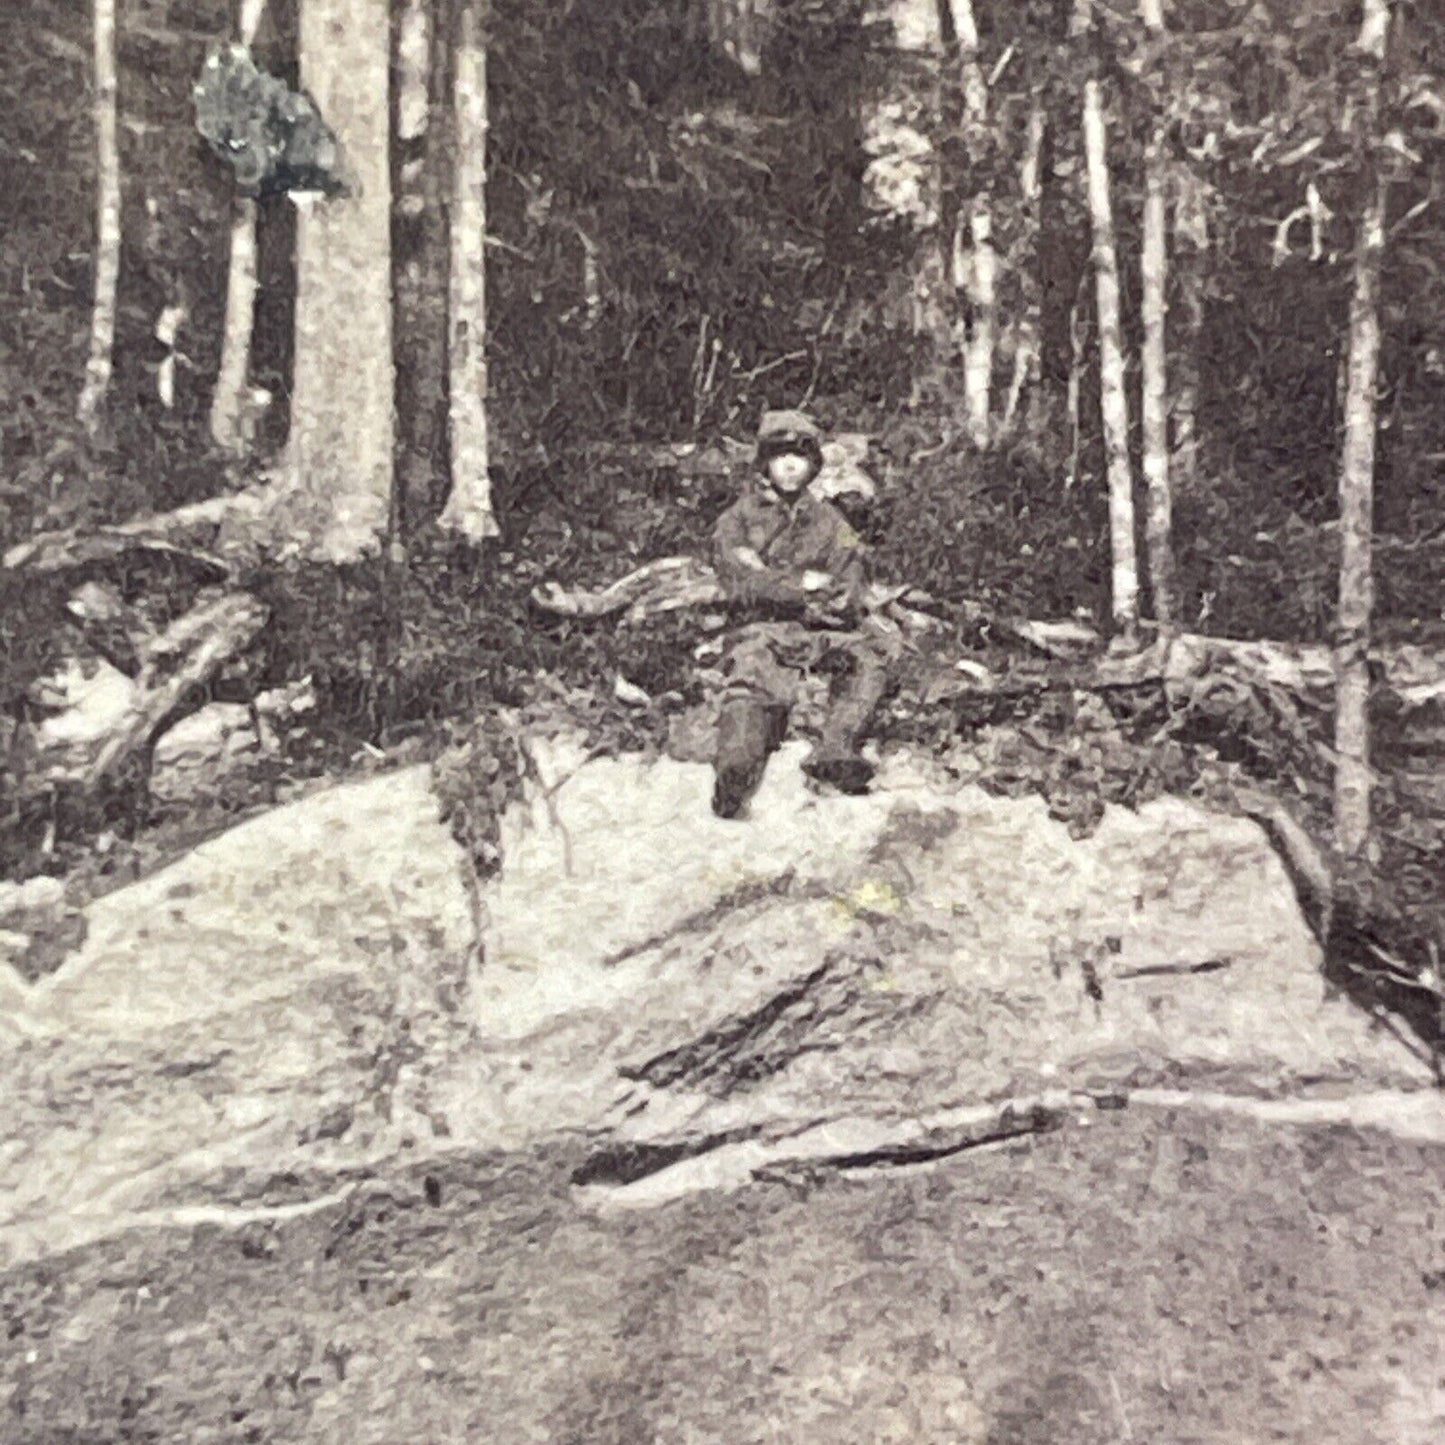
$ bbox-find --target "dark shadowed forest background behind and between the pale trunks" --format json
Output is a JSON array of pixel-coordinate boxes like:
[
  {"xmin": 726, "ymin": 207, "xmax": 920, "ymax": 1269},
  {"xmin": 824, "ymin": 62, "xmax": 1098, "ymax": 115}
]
[{"xmin": 0, "ymin": 0, "xmax": 1445, "ymax": 609}]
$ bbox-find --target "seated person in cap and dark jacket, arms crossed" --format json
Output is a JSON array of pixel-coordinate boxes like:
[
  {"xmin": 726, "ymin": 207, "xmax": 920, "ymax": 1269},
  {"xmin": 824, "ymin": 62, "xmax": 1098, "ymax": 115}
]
[{"xmin": 712, "ymin": 412, "xmax": 894, "ymax": 818}]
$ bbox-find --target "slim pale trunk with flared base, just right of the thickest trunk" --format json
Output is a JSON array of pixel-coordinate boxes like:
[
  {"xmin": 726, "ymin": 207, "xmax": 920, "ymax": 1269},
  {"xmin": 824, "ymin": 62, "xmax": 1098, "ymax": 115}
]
[{"xmin": 439, "ymin": 0, "xmax": 500, "ymax": 543}]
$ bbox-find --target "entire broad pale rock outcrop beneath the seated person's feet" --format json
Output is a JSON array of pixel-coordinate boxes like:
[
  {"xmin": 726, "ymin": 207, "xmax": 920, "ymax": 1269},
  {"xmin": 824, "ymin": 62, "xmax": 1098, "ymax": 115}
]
[{"xmin": 0, "ymin": 741, "xmax": 1445, "ymax": 1259}]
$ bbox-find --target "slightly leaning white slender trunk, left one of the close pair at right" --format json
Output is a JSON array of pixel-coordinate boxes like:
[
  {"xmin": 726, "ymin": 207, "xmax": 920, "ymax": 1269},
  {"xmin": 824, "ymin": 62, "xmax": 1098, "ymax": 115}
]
[{"xmin": 1072, "ymin": 0, "xmax": 1139, "ymax": 643}]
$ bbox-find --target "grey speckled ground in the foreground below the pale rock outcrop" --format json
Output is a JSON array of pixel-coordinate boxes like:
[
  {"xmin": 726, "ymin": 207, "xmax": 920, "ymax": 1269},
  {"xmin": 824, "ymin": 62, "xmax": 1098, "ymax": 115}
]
[{"xmin": 0, "ymin": 1107, "xmax": 1445, "ymax": 1445}]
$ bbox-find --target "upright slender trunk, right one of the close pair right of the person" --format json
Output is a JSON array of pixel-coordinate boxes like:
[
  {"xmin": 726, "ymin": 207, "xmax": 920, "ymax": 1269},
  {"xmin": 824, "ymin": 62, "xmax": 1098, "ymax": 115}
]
[{"xmin": 1139, "ymin": 0, "xmax": 1178, "ymax": 631}]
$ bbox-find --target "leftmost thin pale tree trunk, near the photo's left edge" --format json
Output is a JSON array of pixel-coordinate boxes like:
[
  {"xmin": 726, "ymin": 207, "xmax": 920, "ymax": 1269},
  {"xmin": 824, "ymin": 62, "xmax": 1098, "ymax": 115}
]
[{"xmin": 77, "ymin": 0, "xmax": 120, "ymax": 435}]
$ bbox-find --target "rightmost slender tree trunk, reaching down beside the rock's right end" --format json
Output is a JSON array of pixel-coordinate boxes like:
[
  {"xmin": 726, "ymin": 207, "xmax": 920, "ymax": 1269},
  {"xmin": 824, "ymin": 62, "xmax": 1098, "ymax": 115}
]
[{"xmin": 1335, "ymin": 0, "xmax": 1390, "ymax": 858}]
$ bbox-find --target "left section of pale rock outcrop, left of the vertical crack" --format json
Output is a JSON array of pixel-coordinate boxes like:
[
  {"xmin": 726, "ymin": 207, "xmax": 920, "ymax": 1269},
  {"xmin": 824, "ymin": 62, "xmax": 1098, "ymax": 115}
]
[{"xmin": 0, "ymin": 769, "xmax": 473, "ymax": 1259}]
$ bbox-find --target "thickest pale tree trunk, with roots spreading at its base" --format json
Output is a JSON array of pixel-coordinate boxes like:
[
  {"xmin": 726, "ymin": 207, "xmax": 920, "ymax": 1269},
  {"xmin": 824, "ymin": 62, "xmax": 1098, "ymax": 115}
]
[{"xmin": 289, "ymin": 0, "xmax": 393, "ymax": 562}]
